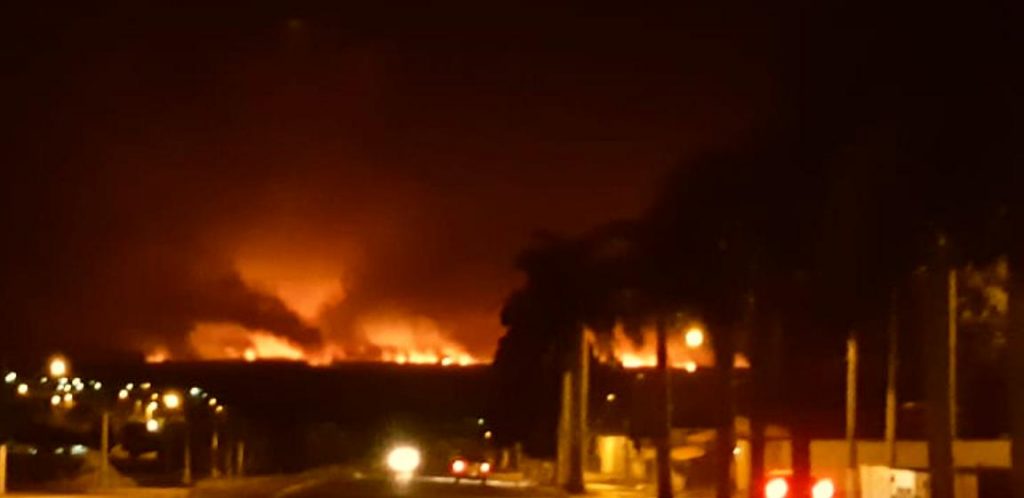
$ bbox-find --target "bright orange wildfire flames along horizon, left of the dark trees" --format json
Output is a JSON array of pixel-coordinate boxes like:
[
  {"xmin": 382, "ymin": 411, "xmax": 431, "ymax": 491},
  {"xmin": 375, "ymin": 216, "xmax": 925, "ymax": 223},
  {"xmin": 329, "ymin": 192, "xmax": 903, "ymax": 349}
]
[{"xmin": 145, "ymin": 259, "xmax": 486, "ymax": 366}]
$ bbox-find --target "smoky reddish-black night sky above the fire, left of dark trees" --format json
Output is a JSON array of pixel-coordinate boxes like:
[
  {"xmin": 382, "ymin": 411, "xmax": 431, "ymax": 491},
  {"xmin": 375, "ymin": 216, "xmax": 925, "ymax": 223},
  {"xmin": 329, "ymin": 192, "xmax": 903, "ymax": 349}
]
[{"xmin": 0, "ymin": 2, "xmax": 795, "ymax": 362}]
